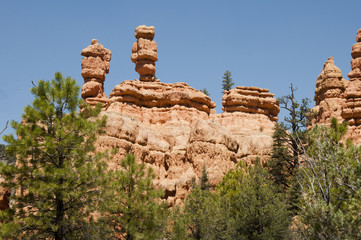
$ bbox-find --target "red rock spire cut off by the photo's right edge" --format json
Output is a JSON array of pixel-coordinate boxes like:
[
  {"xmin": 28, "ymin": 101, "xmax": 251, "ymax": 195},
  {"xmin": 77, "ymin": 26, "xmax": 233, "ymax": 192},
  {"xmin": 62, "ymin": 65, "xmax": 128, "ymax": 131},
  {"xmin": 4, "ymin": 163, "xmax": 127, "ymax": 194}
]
[{"xmin": 342, "ymin": 29, "xmax": 361, "ymax": 144}]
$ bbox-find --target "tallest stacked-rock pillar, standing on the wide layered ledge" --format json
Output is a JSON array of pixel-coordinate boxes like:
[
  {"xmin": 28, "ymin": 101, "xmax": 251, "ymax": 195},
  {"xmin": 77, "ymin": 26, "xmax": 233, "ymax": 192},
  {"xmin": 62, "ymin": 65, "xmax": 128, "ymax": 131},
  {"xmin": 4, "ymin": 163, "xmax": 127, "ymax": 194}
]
[{"xmin": 131, "ymin": 25, "xmax": 158, "ymax": 81}]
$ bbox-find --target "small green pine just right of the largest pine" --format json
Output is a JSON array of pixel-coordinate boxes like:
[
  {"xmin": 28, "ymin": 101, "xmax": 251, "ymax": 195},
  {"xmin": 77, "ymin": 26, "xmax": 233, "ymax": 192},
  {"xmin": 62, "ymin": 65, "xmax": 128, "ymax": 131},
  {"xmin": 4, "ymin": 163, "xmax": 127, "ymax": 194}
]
[{"xmin": 103, "ymin": 154, "xmax": 167, "ymax": 239}]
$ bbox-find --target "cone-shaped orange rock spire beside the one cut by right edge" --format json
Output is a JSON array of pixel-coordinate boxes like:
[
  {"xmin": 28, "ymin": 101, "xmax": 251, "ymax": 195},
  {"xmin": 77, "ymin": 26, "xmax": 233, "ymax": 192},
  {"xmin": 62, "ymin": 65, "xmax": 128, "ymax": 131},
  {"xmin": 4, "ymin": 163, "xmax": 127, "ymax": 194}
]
[{"xmin": 311, "ymin": 57, "xmax": 348, "ymax": 127}]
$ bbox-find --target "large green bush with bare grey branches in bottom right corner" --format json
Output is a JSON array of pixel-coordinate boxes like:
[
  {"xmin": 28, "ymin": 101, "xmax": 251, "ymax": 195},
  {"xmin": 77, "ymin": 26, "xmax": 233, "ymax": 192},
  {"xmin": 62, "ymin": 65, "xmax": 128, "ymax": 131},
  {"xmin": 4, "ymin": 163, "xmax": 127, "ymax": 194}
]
[{"xmin": 296, "ymin": 119, "xmax": 361, "ymax": 239}]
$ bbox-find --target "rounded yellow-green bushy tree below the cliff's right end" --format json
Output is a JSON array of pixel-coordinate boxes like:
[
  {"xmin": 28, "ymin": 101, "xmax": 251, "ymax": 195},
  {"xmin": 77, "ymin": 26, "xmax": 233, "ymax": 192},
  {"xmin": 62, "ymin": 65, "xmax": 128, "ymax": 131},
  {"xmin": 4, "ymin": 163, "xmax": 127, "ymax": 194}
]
[{"xmin": 218, "ymin": 161, "xmax": 290, "ymax": 239}]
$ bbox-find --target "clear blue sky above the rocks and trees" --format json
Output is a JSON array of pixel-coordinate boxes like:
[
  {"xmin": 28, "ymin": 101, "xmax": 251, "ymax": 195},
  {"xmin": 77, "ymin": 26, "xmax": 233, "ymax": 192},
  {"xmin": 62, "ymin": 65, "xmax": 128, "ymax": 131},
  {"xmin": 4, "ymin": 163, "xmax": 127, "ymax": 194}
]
[{"xmin": 0, "ymin": 0, "xmax": 361, "ymax": 143}]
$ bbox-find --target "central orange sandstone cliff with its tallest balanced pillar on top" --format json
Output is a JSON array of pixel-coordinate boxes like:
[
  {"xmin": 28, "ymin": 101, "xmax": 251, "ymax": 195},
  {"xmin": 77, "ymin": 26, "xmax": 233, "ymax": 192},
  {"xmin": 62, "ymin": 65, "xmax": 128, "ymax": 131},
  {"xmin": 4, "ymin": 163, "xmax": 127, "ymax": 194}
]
[{"xmin": 83, "ymin": 26, "xmax": 279, "ymax": 205}]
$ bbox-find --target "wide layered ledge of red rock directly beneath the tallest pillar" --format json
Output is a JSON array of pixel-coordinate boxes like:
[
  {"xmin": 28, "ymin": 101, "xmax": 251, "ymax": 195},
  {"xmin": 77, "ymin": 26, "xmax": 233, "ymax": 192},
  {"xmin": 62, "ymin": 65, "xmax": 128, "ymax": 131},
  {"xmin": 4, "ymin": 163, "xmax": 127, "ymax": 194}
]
[{"xmin": 109, "ymin": 80, "xmax": 216, "ymax": 116}]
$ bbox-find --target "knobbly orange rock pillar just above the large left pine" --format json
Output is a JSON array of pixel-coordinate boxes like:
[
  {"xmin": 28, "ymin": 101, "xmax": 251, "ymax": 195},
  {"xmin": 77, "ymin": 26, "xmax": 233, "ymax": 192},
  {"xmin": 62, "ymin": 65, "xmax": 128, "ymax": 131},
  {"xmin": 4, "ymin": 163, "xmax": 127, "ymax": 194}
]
[{"xmin": 81, "ymin": 39, "xmax": 111, "ymax": 104}]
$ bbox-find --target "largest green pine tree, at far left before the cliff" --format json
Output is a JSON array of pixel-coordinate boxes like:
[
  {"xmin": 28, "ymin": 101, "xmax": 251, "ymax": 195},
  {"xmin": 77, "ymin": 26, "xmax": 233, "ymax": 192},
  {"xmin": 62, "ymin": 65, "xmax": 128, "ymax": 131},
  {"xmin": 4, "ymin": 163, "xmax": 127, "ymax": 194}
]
[{"xmin": 0, "ymin": 73, "xmax": 105, "ymax": 240}]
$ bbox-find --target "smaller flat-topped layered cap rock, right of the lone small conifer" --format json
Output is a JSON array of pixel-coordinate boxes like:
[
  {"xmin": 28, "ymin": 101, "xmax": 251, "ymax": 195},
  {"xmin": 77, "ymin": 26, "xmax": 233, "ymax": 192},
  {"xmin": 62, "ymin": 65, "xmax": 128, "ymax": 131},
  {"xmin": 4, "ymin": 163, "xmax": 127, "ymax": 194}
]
[{"xmin": 222, "ymin": 87, "xmax": 280, "ymax": 121}]
